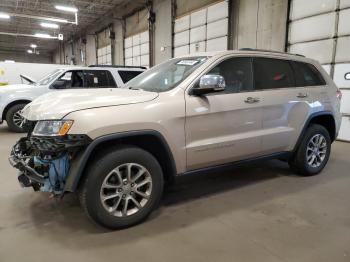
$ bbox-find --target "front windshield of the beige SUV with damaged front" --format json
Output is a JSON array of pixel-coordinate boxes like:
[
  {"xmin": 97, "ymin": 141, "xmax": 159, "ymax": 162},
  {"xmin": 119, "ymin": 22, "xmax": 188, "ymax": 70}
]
[{"xmin": 124, "ymin": 56, "xmax": 208, "ymax": 92}]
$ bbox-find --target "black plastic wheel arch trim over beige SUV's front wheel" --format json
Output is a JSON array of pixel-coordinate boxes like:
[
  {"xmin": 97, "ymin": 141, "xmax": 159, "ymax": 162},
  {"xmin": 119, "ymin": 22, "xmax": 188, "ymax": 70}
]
[{"xmin": 65, "ymin": 130, "xmax": 177, "ymax": 192}]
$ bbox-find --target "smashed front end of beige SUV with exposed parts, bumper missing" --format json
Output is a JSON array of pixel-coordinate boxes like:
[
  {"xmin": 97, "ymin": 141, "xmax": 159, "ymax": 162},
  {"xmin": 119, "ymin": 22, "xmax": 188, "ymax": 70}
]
[{"xmin": 9, "ymin": 123, "xmax": 91, "ymax": 196}]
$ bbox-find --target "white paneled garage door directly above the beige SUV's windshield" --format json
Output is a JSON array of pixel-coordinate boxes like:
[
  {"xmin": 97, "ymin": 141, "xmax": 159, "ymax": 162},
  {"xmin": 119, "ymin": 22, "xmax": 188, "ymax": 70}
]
[{"xmin": 174, "ymin": 1, "xmax": 229, "ymax": 57}]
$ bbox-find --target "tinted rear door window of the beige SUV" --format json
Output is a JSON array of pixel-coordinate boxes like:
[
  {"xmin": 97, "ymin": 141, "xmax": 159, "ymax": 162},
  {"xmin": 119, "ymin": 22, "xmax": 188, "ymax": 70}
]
[{"xmin": 254, "ymin": 58, "xmax": 295, "ymax": 90}]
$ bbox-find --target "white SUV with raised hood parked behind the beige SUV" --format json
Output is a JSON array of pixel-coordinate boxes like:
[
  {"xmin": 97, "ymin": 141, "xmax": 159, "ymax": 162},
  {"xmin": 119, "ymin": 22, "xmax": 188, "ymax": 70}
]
[{"xmin": 0, "ymin": 66, "xmax": 146, "ymax": 132}]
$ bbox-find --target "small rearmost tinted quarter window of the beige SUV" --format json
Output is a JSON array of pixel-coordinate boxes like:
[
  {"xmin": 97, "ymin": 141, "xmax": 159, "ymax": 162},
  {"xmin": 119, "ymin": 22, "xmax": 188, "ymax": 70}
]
[{"xmin": 293, "ymin": 62, "xmax": 326, "ymax": 86}]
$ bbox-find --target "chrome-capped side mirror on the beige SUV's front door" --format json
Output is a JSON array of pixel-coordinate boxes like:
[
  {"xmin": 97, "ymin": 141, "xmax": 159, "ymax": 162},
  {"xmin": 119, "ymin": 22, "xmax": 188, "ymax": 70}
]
[{"xmin": 192, "ymin": 75, "xmax": 226, "ymax": 95}]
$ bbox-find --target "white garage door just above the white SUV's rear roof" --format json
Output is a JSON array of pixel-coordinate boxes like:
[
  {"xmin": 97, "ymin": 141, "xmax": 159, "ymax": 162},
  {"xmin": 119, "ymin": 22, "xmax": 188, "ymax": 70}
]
[{"xmin": 124, "ymin": 31, "xmax": 149, "ymax": 67}]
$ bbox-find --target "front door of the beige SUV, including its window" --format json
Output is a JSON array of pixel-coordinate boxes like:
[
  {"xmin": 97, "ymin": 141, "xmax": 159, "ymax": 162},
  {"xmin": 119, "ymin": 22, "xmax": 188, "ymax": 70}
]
[{"xmin": 185, "ymin": 57, "xmax": 262, "ymax": 170}]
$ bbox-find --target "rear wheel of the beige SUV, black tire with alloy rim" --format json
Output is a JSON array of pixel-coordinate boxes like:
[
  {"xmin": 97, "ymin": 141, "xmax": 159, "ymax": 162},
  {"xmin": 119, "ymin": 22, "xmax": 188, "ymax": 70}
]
[{"xmin": 289, "ymin": 124, "xmax": 331, "ymax": 176}]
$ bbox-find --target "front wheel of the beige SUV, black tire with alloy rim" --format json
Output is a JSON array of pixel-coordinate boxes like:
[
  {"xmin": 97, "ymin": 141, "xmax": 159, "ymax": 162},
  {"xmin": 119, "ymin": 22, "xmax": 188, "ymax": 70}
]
[{"xmin": 79, "ymin": 146, "xmax": 164, "ymax": 229}]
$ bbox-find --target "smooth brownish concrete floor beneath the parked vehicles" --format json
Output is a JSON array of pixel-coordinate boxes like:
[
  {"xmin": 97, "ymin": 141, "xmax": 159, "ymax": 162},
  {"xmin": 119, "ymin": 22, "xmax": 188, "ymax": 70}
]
[{"xmin": 0, "ymin": 125, "xmax": 350, "ymax": 262}]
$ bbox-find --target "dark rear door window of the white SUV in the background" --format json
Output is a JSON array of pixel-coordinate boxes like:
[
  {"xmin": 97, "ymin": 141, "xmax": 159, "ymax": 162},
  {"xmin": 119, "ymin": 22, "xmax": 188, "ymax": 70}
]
[{"xmin": 85, "ymin": 70, "xmax": 117, "ymax": 88}]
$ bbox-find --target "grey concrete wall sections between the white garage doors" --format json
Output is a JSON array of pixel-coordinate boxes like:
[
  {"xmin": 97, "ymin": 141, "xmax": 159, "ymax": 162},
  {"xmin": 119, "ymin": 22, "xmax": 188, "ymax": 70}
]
[{"xmin": 53, "ymin": 0, "xmax": 288, "ymax": 65}]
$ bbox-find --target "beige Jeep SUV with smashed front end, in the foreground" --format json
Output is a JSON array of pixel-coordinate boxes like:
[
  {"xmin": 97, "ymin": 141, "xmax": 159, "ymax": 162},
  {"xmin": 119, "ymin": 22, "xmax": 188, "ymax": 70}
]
[{"xmin": 10, "ymin": 50, "xmax": 341, "ymax": 229}]
